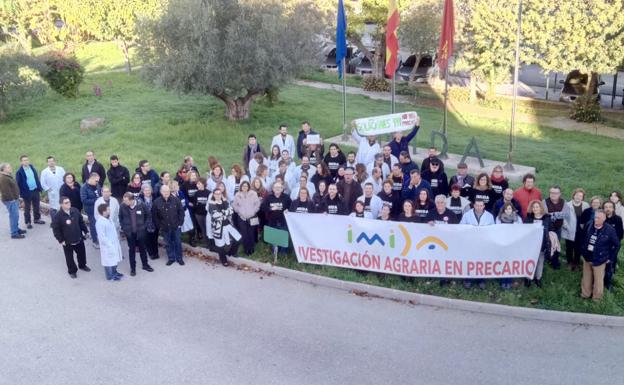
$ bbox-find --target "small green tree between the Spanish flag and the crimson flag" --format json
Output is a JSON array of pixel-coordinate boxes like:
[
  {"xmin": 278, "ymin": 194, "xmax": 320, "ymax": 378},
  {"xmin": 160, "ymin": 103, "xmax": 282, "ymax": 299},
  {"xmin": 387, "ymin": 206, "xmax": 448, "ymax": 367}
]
[{"xmin": 400, "ymin": 0, "xmax": 443, "ymax": 80}]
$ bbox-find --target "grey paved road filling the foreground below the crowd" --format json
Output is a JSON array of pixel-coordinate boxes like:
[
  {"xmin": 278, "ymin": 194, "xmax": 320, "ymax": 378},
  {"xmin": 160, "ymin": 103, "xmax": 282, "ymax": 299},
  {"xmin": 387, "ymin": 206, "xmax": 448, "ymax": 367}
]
[{"xmin": 0, "ymin": 209, "xmax": 624, "ymax": 385}]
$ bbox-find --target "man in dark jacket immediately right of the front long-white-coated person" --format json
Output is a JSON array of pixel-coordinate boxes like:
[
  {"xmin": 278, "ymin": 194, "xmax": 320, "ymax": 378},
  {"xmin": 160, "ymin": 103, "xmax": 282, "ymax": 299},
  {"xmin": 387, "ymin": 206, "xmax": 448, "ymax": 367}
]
[{"xmin": 119, "ymin": 192, "xmax": 154, "ymax": 277}]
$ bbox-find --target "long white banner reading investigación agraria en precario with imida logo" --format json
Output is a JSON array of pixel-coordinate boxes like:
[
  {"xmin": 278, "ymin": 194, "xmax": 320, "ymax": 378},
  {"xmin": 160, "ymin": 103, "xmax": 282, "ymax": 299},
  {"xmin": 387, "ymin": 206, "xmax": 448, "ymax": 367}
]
[{"xmin": 286, "ymin": 212, "xmax": 543, "ymax": 278}]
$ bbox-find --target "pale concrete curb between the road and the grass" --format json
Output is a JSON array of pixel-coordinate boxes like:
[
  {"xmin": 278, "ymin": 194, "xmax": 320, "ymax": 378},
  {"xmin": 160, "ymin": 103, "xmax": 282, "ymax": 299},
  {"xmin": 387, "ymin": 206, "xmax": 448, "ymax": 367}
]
[{"xmin": 41, "ymin": 202, "xmax": 624, "ymax": 328}]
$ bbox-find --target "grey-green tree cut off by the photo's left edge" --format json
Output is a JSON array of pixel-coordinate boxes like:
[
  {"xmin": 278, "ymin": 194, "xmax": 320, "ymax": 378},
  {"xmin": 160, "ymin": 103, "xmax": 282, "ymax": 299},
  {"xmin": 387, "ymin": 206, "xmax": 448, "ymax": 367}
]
[{"xmin": 0, "ymin": 45, "xmax": 45, "ymax": 122}]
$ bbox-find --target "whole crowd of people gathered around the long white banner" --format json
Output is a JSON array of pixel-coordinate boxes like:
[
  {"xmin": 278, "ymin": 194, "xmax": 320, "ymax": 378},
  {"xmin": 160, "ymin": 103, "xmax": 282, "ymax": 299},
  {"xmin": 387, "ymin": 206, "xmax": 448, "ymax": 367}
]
[{"xmin": 0, "ymin": 122, "xmax": 624, "ymax": 300}]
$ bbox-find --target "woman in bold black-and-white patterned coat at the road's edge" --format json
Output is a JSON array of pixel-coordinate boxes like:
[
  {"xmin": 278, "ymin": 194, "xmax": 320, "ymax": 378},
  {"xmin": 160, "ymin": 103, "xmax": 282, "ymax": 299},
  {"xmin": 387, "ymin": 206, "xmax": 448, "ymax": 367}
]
[{"xmin": 206, "ymin": 189, "xmax": 241, "ymax": 266}]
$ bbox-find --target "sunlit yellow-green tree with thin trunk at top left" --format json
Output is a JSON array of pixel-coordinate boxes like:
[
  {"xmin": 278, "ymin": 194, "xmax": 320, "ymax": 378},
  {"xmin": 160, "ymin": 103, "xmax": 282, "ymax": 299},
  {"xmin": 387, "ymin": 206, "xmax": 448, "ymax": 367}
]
[{"xmin": 56, "ymin": 0, "xmax": 163, "ymax": 72}]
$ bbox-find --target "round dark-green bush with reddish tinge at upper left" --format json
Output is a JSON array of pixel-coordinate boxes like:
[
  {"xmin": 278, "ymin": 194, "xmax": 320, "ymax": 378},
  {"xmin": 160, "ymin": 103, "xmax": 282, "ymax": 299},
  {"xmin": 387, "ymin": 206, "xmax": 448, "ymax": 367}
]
[{"xmin": 43, "ymin": 52, "xmax": 84, "ymax": 98}]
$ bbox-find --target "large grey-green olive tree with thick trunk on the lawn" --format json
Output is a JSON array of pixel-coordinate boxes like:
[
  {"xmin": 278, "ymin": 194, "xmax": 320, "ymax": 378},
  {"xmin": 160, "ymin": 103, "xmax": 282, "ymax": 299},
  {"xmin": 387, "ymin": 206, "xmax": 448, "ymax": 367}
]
[{"xmin": 139, "ymin": 0, "xmax": 319, "ymax": 120}]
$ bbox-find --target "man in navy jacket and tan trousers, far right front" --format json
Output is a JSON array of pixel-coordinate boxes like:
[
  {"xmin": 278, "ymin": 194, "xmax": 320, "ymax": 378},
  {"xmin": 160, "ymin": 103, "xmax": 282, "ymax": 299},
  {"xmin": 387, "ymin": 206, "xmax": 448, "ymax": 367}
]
[{"xmin": 581, "ymin": 209, "xmax": 620, "ymax": 301}]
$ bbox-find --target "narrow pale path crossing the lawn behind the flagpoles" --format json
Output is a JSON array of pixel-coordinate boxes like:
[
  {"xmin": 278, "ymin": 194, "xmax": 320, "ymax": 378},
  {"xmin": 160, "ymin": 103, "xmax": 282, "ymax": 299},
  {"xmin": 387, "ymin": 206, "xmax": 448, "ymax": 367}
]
[{"xmin": 294, "ymin": 80, "xmax": 624, "ymax": 140}]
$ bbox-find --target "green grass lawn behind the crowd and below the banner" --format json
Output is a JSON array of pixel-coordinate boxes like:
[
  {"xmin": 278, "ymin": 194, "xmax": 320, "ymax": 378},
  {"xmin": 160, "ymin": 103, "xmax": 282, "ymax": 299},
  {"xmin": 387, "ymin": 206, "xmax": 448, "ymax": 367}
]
[{"xmin": 0, "ymin": 69, "xmax": 624, "ymax": 315}]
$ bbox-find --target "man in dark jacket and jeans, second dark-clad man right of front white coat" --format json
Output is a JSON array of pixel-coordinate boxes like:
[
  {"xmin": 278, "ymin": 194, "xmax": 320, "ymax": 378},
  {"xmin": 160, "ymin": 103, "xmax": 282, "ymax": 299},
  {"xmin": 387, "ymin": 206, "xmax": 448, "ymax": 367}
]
[{"xmin": 152, "ymin": 186, "xmax": 184, "ymax": 266}]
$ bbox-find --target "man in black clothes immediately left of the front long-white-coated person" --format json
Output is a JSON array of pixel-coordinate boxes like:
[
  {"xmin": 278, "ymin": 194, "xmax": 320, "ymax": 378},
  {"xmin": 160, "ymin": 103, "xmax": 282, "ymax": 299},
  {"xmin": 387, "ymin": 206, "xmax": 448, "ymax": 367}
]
[{"xmin": 52, "ymin": 196, "xmax": 91, "ymax": 278}]
